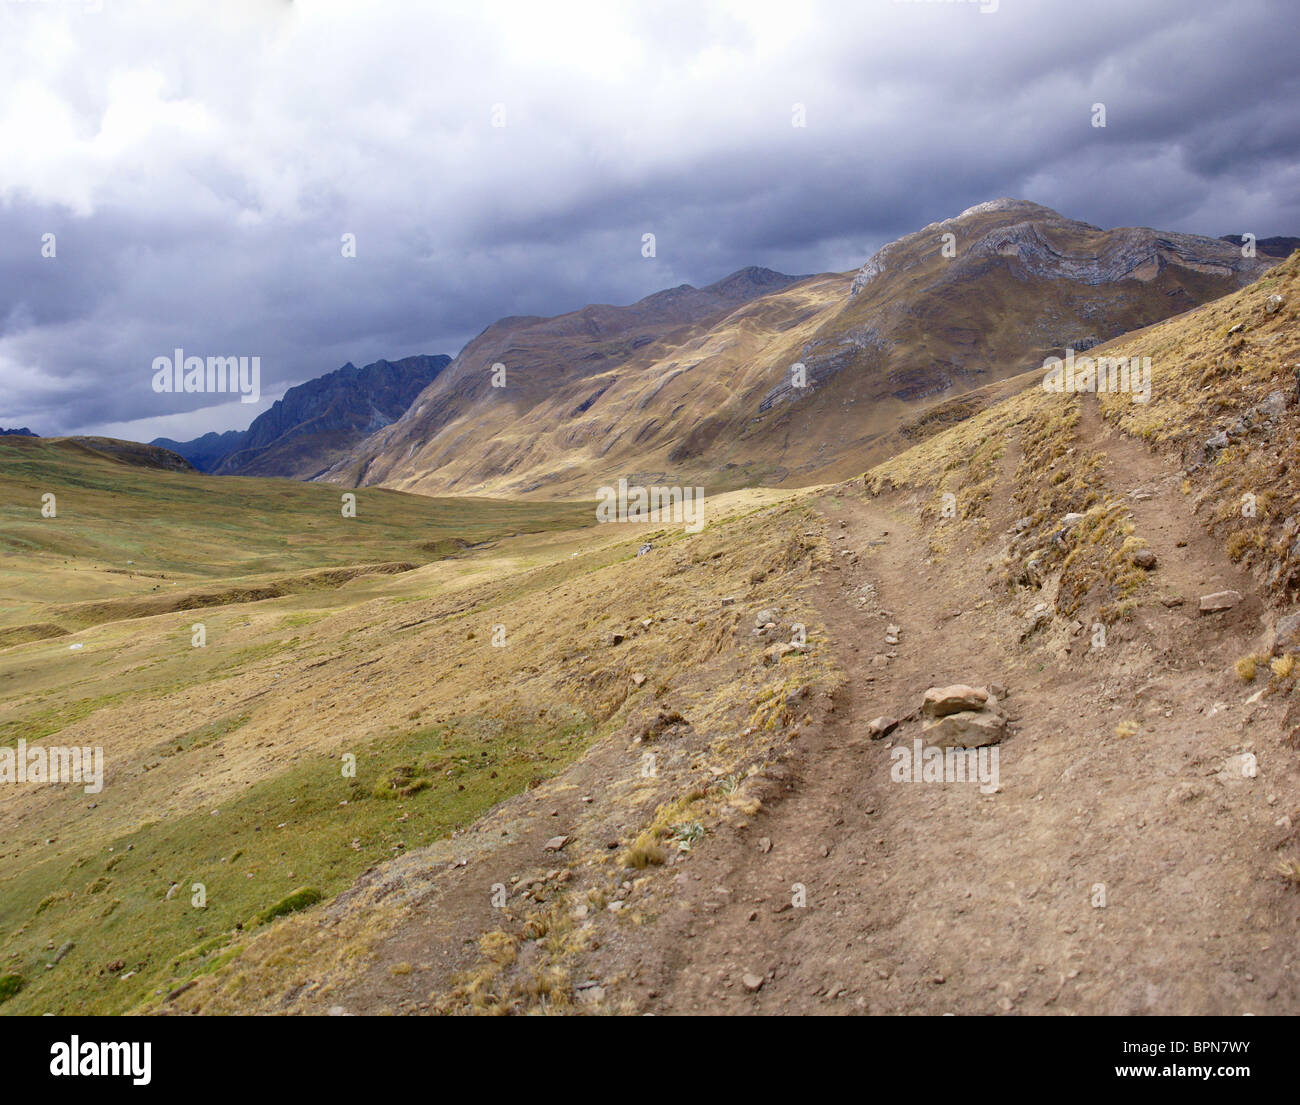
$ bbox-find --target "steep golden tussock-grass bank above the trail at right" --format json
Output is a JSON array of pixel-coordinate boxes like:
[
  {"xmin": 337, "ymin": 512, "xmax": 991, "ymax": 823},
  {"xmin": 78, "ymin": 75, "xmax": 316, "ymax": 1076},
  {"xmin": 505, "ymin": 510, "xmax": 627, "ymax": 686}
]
[{"xmin": 865, "ymin": 254, "xmax": 1300, "ymax": 621}]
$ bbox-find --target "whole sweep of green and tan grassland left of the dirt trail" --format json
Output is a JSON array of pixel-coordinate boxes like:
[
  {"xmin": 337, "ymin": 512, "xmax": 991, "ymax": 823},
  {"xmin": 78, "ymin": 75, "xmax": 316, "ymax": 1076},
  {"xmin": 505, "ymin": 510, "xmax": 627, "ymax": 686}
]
[{"xmin": 0, "ymin": 428, "xmax": 811, "ymax": 1013}]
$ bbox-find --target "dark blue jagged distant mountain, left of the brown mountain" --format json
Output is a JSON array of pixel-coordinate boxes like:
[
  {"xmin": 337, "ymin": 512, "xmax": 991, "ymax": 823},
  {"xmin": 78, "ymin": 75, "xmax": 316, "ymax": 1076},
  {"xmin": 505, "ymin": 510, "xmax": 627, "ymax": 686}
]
[{"xmin": 152, "ymin": 354, "xmax": 451, "ymax": 480}]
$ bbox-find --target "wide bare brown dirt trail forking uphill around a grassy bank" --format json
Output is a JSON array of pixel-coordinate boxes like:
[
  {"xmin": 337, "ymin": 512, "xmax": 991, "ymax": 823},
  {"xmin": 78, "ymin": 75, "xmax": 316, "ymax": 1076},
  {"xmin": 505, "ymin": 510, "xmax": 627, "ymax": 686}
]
[{"xmin": 639, "ymin": 400, "xmax": 1300, "ymax": 1014}]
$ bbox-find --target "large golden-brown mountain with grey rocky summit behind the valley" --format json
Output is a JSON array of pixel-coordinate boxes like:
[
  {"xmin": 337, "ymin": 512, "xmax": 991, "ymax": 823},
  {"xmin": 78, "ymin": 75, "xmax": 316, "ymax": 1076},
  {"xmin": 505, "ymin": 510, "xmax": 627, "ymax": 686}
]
[{"xmin": 322, "ymin": 199, "xmax": 1277, "ymax": 497}]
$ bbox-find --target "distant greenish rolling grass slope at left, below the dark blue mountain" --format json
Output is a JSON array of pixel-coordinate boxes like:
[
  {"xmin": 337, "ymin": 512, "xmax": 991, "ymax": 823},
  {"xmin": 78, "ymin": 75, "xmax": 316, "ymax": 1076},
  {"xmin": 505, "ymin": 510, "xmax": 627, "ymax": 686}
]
[{"xmin": 0, "ymin": 437, "xmax": 594, "ymax": 637}]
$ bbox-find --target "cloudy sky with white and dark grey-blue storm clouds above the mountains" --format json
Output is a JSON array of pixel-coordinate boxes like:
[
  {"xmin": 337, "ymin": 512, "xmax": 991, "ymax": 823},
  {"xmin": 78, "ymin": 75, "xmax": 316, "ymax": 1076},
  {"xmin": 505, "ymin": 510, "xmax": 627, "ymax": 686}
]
[{"xmin": 0, "ymin": 0, "xmax": 1300, "ymax": 441}]
